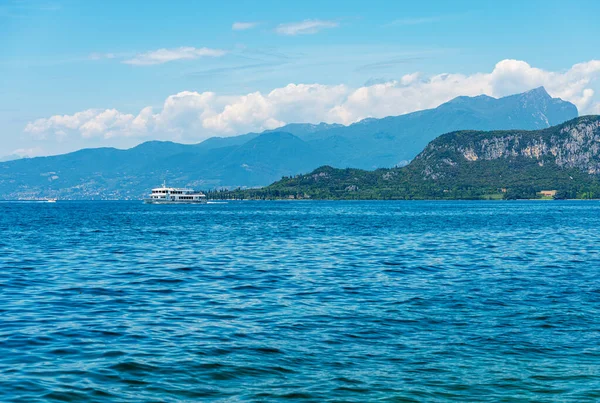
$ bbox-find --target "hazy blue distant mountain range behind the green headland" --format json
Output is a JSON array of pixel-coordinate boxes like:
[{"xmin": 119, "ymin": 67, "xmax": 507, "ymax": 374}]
[{"xmin": 0, "ymin": 87, "xmax": 577, "ymax": 199}]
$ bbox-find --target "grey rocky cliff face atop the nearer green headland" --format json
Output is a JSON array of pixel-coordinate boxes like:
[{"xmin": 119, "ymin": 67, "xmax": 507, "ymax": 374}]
[{"xmin": 415, "ymin": 116, "xmax": 600, "ymax": 180}]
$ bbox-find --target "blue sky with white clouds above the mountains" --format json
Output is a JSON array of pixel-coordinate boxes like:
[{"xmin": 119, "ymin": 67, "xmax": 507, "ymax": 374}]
[{"xmin": 0, "ymin": 0, "xmax": 600, "ymax": 157}]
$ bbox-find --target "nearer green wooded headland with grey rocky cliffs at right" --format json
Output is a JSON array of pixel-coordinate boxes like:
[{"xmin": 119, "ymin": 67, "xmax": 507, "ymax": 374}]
[{"xmin": 238, "ymin": 116, "xmax": 600, "ymax": 199}]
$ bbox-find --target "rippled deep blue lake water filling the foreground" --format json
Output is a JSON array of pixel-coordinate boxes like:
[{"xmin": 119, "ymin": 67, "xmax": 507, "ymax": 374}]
[{"xmin": 0, "ymin": 201, "xmax": 600, "ymax": 402}]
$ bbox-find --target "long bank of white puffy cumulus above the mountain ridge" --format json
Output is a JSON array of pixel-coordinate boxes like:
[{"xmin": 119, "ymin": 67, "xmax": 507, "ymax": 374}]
[{"xmin": 25, "ymin": 60, "xmax": 600, "ymax": 141}]
